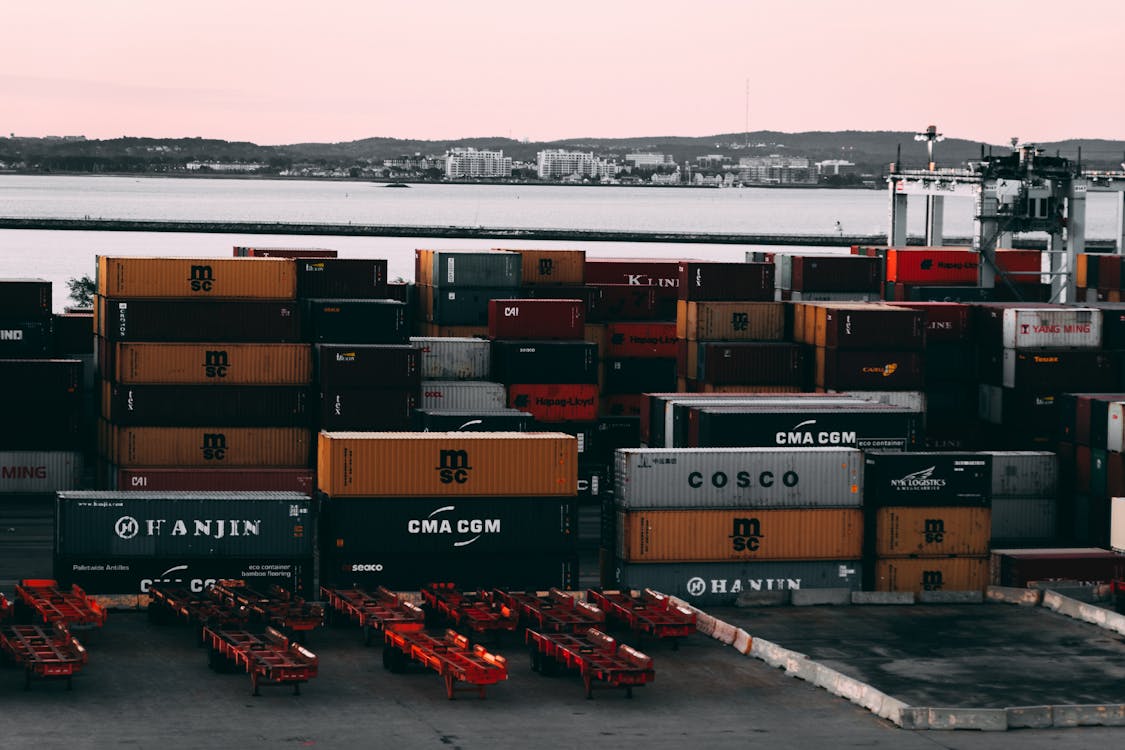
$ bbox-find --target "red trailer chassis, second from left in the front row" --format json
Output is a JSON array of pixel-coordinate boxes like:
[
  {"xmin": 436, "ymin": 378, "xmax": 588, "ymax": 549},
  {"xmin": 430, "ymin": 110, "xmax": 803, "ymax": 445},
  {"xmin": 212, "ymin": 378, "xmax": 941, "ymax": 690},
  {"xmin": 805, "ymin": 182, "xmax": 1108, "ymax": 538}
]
[{"xmin": 204, "ymin": 625, "xmax": 320, "ymax": 696}]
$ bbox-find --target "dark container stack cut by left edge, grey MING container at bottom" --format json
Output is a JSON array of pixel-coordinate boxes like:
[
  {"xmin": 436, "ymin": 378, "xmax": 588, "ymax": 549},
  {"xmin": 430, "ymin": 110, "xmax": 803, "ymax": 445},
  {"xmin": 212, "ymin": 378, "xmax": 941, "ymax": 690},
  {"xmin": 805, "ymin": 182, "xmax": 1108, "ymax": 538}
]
[{"xmin": 0, "ymin": 279, "xmax": 90, "ymax": 495}]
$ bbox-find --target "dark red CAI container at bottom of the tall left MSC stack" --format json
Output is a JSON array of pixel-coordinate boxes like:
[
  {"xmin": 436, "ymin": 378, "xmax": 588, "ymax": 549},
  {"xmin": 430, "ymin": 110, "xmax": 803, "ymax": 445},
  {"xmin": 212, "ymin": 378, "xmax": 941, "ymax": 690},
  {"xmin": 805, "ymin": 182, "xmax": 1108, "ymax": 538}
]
[{"xmin": 113, "ymin": 467, "xmax": 316, "ymax": 495}]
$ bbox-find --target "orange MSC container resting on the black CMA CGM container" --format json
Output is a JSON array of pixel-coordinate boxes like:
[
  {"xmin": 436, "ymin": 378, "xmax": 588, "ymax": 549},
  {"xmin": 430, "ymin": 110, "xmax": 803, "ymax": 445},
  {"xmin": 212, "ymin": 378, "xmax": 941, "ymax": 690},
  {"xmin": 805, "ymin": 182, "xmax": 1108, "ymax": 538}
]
[{"xmin": 316, "ymin": 432, "xmax": 578, "ymax": 497}]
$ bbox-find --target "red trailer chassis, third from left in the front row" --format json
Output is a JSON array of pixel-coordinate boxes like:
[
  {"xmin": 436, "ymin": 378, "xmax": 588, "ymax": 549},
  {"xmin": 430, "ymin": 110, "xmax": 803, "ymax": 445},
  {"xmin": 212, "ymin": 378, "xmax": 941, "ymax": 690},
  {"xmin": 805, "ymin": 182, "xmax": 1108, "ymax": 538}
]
[{"xmin": 383, "ymin": 630, "xmax": 507, "ymax": 701}]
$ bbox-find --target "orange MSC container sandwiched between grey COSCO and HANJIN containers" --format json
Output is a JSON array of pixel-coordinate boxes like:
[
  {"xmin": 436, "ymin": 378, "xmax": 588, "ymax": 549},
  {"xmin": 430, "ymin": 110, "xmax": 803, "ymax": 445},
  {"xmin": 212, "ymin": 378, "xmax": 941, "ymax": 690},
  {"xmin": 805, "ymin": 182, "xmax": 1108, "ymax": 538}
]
[{"xmin": 618, "ymin": 508, "xmax": 863, "ymax": 562}]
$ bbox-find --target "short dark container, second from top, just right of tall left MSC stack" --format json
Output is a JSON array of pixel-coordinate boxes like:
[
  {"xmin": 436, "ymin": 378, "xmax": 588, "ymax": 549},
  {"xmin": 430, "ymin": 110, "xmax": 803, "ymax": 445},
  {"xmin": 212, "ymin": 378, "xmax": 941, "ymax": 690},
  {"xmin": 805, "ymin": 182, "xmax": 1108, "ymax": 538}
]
[{"xmin": 305, "ymin": 299, "xmax": 410, "ymax": 344}]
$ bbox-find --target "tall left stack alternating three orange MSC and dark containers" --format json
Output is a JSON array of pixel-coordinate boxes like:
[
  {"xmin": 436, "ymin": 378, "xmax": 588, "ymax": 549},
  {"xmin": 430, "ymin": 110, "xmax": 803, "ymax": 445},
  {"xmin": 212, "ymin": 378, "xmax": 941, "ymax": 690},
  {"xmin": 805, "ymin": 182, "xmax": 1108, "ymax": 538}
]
[{"xmin": 96, "ymin": 256, "xmax": 315, "ymax": 493}]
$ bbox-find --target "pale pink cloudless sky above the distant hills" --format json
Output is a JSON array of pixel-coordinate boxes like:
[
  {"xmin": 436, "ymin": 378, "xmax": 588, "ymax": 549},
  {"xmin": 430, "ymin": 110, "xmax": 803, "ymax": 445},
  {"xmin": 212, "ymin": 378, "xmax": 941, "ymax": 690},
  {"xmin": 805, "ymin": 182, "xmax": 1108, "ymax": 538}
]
[{"xmin": 0, "ymin": 0, "xmax": 1125, "ymax": 145}]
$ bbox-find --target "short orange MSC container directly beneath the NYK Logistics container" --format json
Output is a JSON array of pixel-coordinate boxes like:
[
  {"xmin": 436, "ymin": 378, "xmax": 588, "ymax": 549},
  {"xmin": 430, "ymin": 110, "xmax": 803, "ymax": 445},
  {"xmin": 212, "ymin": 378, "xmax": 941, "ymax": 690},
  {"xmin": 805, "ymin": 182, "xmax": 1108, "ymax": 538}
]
[{"xmin": 875, "ymin": 507, "xmax": 992, "ymax": 558}]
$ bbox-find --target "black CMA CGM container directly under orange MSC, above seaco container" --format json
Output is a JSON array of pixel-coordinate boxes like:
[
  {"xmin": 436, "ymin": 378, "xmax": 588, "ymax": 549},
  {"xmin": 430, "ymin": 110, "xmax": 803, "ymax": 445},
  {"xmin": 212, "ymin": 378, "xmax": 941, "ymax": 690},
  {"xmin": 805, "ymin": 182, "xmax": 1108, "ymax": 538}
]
[{"xmin": 320, "ymin": 497, "xmax": 578, "ymax": 557}]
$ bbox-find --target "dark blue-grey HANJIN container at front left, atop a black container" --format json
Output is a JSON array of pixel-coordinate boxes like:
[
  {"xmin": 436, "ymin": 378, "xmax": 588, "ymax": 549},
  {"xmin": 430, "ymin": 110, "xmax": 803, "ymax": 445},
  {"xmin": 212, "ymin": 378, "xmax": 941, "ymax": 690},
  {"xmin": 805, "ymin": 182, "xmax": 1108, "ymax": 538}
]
[{"xmin": 55, "ymin": 491, "xmax": 316, "ymax": 558}]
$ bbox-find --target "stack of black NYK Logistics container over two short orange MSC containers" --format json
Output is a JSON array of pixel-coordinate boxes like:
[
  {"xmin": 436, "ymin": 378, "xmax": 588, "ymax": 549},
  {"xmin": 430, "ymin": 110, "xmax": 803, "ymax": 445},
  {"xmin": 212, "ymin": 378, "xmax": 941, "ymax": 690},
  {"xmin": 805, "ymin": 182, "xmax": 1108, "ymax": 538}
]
[{"xmin": 863, "ymin": 451, "xmax": 992, "ymax": 594}]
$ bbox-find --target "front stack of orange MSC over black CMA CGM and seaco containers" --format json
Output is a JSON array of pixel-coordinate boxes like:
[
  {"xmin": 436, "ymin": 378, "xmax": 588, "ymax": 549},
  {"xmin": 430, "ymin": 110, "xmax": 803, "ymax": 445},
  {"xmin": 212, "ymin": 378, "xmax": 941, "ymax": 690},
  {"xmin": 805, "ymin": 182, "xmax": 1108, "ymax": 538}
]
[{"xmin": 317, "ymin": 432, "xmax": 577, "ymax": 590}]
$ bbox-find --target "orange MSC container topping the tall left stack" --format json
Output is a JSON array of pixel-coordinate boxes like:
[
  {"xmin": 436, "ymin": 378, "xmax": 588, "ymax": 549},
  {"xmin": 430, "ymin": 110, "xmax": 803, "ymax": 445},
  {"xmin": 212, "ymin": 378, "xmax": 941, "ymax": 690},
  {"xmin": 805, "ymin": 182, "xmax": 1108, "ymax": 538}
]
[{"xmin": 98, "ymin": 255, "xmax": 297, "ymax": 299}]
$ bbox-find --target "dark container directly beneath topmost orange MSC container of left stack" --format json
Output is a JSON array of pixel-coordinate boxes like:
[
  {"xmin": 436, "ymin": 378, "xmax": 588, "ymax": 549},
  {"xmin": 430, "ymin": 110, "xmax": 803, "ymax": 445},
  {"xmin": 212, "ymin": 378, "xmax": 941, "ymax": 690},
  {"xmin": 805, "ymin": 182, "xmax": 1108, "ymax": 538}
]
[{"xmin": 96, "ymin": 297, "xmax": 304, "ymax": 343}]
